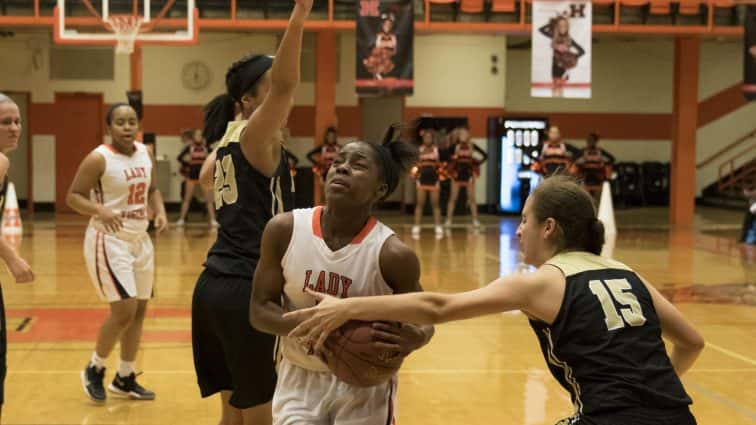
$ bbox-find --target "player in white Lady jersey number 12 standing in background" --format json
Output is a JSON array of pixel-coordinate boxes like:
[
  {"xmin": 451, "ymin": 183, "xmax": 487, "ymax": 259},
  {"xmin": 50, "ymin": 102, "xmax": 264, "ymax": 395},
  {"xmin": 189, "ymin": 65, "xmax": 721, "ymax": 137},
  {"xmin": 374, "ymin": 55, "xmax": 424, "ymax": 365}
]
[{"xmin": 66, "ymin": 103, "xmax": 167, "ymax": 402}]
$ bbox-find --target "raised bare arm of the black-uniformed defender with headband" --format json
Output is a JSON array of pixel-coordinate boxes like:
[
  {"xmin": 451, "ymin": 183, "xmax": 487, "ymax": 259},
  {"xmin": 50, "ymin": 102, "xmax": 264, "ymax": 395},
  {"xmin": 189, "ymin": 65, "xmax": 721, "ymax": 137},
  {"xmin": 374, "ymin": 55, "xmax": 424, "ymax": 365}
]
[{"xmin": 240, "ymin": 0, "xmax": 313, "ymax": 177}]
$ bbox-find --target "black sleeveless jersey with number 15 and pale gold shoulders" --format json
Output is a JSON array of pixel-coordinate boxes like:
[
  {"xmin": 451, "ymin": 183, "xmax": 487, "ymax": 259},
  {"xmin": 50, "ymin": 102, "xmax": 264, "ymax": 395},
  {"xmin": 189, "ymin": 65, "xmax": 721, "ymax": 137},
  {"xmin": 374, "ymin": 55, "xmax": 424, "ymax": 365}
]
[{"xmin": 530, "ymin": 252, "xmax": 691, "ymax": 423}]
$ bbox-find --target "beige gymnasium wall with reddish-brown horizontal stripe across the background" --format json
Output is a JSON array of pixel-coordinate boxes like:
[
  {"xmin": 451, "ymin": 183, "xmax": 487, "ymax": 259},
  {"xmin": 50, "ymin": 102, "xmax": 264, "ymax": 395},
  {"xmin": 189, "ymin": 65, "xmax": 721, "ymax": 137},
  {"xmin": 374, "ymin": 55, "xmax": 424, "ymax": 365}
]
[{"xmin": 0, "ymin": 32, "xmax": 756, "ymax": 202}]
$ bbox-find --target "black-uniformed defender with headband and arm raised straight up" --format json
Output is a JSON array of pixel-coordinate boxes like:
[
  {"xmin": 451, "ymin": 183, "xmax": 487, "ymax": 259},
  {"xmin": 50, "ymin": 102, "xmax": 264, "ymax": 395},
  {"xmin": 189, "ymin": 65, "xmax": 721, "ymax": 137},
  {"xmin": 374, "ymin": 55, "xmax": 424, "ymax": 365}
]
[{"xmin": 192, "ymin": 0, "xmax": 312, "ymax": 425}]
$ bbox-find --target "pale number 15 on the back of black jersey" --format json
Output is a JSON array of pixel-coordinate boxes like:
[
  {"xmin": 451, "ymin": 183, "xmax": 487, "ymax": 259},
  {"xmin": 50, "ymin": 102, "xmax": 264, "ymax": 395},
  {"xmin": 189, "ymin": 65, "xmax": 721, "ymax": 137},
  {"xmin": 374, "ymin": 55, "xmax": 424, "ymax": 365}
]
[{"xmin": 588, "ymin": 279, "xmax": 646, "ymax": 331}]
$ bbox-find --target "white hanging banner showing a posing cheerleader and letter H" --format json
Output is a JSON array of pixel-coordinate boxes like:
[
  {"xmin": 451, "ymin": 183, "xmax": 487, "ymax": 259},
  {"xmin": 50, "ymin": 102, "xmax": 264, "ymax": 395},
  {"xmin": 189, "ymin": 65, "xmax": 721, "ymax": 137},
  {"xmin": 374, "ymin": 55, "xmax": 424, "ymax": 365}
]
[{"xmin": 530, "ymin": 0, "xmax": 592, "ymax": 98}]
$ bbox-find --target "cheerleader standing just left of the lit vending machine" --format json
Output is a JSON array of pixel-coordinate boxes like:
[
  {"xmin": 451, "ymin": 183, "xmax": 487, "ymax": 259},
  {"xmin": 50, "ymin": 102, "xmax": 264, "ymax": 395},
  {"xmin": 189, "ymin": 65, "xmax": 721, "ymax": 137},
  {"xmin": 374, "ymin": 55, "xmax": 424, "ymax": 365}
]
[{"xmin": 446, "ymin": 127, "xmax": 488, "ymax": 227}]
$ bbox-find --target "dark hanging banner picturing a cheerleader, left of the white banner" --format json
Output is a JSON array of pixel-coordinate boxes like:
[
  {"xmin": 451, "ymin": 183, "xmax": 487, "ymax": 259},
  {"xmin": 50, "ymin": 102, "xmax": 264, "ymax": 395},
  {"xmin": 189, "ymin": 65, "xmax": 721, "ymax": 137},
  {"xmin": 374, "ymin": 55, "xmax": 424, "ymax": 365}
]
[{"xmin": 355, "ymin": 0, "xmax": 414, "ymax": 96}]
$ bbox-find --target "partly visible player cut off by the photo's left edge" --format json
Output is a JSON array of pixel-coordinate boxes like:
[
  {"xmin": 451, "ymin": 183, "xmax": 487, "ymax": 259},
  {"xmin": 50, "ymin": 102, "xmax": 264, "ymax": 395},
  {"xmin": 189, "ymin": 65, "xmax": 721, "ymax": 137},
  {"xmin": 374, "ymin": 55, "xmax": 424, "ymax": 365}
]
[{"xmin": 0, "ymin": 93, "xmax": 34, "ymax": 418}]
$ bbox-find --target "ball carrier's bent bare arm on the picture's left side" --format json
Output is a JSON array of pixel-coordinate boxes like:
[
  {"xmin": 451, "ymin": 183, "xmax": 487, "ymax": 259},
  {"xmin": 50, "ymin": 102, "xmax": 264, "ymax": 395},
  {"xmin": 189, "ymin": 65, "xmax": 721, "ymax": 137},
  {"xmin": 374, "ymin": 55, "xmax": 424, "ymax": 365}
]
[{"xmin": 249, "ymin": 212, "xmax": 300, "ymax": 335}]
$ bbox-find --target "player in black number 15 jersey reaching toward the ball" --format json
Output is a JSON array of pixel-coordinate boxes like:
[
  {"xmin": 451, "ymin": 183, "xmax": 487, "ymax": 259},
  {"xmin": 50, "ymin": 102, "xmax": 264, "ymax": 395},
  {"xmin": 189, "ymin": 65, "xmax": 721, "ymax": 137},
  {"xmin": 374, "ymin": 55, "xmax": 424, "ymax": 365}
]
[{"xmin": 284, "ymin": 177, "xmax": 704, "ymax": 425}]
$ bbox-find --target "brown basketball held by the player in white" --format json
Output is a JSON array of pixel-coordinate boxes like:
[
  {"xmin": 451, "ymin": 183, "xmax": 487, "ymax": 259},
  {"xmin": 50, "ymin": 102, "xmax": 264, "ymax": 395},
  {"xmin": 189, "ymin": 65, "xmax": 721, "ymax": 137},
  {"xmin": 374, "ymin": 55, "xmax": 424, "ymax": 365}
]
[{"xmin": 323, "ymin": 320, "xmax": 404, "ymax": 387}]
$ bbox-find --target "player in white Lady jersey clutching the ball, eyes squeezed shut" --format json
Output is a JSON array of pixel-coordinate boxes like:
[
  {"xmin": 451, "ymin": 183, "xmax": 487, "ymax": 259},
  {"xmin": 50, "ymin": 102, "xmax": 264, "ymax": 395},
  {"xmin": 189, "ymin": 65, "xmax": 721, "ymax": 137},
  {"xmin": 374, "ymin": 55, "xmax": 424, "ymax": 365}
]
[{"xmin": 250, "ymin": 124, "xmax": 433, "ymax": 425}]
